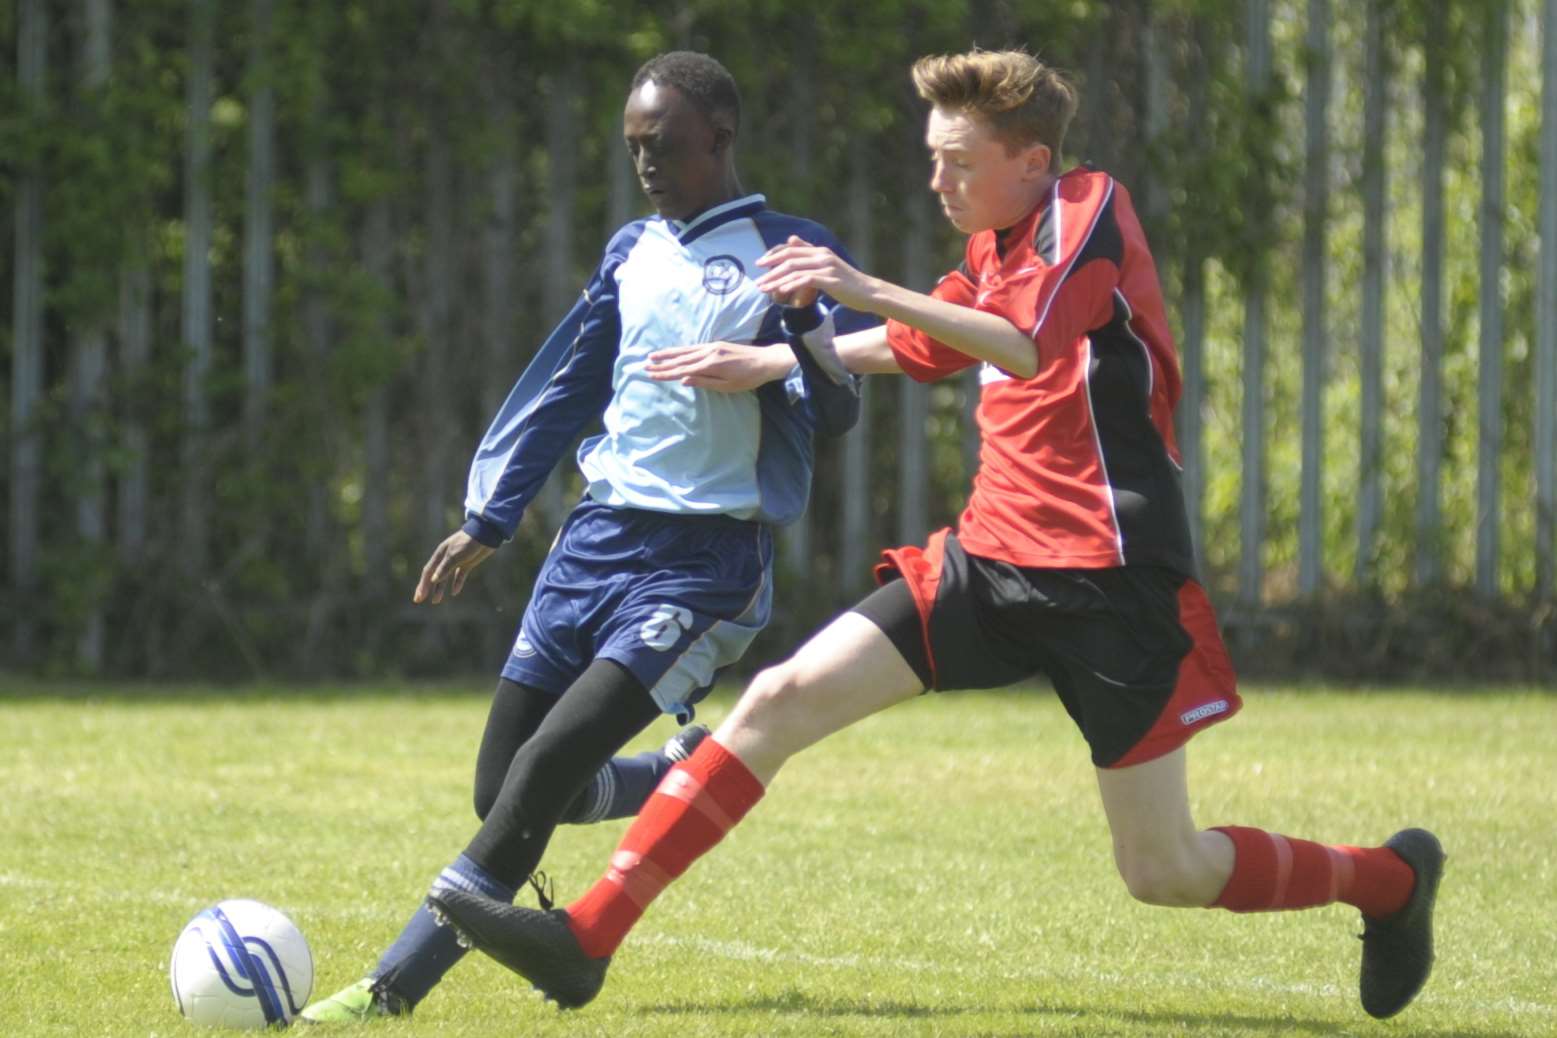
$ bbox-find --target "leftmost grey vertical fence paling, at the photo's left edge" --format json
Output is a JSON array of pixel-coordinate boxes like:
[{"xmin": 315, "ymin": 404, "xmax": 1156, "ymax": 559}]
[{"xmin": 11, "ymin": 0, "xmax": 48, "ymax": 661}]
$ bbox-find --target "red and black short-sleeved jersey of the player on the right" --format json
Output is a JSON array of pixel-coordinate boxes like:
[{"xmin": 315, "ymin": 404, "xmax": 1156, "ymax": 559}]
[{"xmin": 887, "ymin": 167, "xmax": 1194, "ymax": 576}]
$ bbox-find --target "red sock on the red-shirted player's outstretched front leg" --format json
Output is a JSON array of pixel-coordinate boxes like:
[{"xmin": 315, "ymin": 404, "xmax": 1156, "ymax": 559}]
[{"xmin": 567, "ymin": 739, "xmax": 763, "ymax": 959}]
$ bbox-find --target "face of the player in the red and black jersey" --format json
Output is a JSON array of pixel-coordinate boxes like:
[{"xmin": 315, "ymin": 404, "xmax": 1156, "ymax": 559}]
[{"xmin": 925, "ymin": 107, "xmax": 1053, "ymax": 235}]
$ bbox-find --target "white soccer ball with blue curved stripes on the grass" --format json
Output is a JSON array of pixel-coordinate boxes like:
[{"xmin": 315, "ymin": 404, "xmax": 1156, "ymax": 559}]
[{"xmin": 168, "ymin": 898, "xmax": 313, "ymax": 1029}]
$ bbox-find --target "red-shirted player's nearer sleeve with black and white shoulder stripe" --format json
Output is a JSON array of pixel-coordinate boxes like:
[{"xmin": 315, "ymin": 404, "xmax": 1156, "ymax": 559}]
[{"xmin": 976, "ymin": 177, "xmax": 1123, "ymax": 356}]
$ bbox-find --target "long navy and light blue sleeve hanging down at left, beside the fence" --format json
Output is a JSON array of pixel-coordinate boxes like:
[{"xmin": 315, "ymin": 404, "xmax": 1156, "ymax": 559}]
[{"xmin": 462, "ymin": 238, "xmax": 637, "ymax": 548}]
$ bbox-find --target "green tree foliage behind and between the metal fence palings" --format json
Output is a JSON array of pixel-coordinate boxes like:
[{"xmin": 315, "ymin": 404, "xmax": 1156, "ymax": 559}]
[{"xmin": 0, "ymin": 0, "xmax": 1549, "ymax": 674}]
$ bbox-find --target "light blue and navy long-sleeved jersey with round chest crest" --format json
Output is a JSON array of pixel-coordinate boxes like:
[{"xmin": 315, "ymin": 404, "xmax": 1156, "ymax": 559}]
[{"xmin": 466, "ymin": 195, "xmax": 877, "ymax": 545}]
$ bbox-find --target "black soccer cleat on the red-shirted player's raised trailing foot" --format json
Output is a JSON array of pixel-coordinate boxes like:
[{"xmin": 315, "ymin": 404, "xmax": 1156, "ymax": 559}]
[{"xmin": 1359, "ymin": 829, "xmax": 1443, "ymax": 1019}]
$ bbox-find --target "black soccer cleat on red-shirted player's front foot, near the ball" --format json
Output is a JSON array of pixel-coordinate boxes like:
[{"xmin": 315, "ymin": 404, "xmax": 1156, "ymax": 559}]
[{"xmin": 427, "ymin": 890, "xmax": 610, "ymax": 1008}]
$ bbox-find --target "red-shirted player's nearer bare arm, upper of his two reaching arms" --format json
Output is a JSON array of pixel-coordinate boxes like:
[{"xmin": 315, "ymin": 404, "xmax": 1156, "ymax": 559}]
[{"xmin": 757, "ymin": 238, "xmax": 1039, "ymax": 378}]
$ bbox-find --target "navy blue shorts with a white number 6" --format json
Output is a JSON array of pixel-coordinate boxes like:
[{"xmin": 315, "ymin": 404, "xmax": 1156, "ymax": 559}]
[{"xmin": 503, "ymin": 500, "xmax": 774, "ymax": 724}]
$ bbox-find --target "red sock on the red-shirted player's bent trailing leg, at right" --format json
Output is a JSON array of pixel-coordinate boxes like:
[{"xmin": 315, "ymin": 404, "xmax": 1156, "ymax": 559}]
[{"xmin": 1211, "ymin": 826, "xmax": 1417, "ymax": 918}]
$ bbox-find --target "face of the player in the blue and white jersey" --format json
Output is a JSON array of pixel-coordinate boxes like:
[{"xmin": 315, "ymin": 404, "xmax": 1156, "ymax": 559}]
[{"xmin": 621, "ymin": 81, "xmax": 732, "ymax": 219}]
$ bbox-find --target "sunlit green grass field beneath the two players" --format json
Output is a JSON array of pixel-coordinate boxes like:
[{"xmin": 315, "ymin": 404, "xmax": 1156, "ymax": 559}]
[{"xmin": 0, "ymin": 680, "xmax": 1557, "ymax": 1038}]
